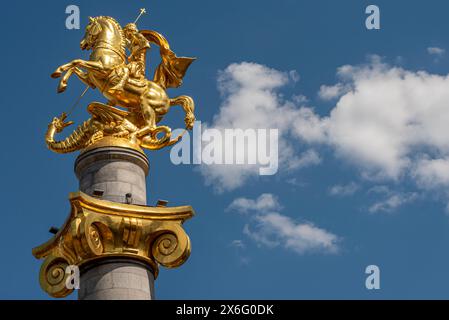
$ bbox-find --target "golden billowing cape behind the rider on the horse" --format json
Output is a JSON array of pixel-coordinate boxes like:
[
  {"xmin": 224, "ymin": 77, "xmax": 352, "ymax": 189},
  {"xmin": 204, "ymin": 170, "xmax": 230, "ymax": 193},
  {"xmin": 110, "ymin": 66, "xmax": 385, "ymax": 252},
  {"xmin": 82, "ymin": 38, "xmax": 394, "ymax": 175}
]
[{"xmin": 140, "ymin": 30, "xmax": 196, "ymax": 88}]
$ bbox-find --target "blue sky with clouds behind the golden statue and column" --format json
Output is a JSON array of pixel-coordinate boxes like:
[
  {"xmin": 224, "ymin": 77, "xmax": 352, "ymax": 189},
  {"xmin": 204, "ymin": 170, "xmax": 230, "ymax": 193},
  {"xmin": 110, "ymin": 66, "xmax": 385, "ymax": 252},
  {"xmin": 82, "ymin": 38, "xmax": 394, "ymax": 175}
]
[{"xmin": 0, "ymin": 0, "xmax": 449, "ymax": 299}]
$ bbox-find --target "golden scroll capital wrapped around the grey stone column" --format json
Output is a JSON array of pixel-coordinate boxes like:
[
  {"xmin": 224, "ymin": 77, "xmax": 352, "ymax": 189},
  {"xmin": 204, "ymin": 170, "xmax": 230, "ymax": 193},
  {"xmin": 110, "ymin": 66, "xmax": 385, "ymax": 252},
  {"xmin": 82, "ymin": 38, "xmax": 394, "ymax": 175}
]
[{"xmin": 33, "ymin": 192, "xmax": 194, "ymax": 298}]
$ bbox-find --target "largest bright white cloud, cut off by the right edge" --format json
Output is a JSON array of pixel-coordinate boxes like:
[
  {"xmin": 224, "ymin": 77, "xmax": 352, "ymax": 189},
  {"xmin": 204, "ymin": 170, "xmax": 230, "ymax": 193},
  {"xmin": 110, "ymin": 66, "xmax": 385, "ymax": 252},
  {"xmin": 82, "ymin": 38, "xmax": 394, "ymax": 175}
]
[{"xmin": 296, "ymin": 57, "xmax": 449, "ymax": 196}]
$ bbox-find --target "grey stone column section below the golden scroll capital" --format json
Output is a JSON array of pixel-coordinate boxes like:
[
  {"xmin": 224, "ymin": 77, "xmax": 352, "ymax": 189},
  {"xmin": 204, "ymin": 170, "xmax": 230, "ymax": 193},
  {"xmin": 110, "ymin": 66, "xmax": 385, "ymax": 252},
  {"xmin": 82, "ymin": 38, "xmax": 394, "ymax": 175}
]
[{"xmin": 78, "ymin": 259, "xmax": 154, "ymax": 300}]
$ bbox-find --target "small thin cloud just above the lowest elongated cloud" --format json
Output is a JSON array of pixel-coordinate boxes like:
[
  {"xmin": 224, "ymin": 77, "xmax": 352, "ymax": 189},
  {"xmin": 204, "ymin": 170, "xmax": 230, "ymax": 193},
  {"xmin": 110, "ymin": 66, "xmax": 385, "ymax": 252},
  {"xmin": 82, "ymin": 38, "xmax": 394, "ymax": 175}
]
[{"xmin": 226, "ymin": 193, "xmax": 281, "ymax": 213}]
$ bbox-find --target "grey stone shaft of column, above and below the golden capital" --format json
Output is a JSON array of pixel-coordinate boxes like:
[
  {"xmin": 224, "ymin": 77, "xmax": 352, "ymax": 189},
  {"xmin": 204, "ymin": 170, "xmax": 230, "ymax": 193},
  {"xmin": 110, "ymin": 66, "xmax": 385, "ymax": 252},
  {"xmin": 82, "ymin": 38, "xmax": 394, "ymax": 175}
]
[{"xmin": 75, "ymin": 146, "xmax": 154, "ymax": 300}]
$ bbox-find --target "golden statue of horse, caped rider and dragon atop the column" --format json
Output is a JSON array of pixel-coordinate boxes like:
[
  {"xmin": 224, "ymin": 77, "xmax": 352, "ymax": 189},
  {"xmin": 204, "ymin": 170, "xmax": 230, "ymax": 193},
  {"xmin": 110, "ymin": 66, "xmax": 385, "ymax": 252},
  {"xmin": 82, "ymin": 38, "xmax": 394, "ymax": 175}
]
[{"xmin": 46, "ymin": 11, "xmax": 195, "ymax": 153}]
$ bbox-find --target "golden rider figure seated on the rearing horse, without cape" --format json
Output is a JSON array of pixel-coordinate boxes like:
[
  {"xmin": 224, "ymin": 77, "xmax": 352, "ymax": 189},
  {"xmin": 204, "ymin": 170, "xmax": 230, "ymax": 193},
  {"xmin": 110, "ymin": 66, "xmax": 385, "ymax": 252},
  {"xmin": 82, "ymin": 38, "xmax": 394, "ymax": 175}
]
[{"xmin": 111, "ymin": 23, "xmax": 150, "ymax": 90}]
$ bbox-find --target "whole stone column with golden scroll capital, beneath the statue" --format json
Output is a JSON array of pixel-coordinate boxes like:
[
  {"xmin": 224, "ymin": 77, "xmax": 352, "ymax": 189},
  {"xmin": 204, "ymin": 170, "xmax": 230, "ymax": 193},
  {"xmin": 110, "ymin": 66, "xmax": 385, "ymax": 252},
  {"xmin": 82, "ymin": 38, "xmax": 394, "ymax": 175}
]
[{"xmin": 33, "ymin": 138, "xmax": 194, "ymax": 300}]
